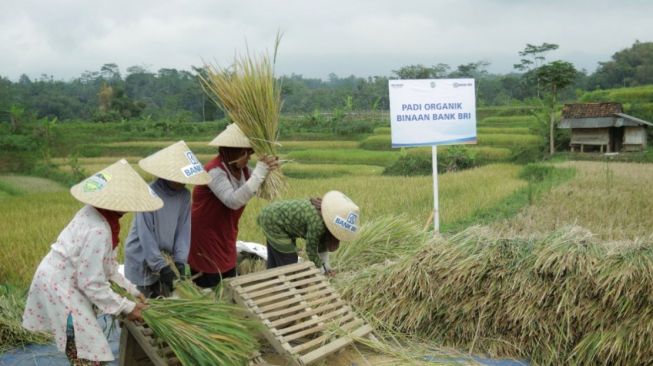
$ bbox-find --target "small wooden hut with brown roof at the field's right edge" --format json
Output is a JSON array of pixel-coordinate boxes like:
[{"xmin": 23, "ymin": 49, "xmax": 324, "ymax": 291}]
[{"xmin": 558, "ymin": 103, "xmax": 653, "ymax": 152}]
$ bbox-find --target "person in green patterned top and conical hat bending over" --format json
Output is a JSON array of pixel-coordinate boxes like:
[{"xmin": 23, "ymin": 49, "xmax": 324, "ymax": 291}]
[{"xmin": 257, "ymin": 191, "xmax": 360, "ymax": 276}]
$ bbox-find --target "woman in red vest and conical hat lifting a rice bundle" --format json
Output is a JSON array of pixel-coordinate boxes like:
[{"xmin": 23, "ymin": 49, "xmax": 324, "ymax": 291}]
[{"xmin": 188, "ymin": 124, "xmax": 278, "ymax": 288}]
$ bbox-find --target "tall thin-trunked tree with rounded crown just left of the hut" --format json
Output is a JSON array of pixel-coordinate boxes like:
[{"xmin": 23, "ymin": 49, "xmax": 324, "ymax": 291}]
[{"xmin": 537, "ymin": 60, "xmax": 578, "ymax": 155}]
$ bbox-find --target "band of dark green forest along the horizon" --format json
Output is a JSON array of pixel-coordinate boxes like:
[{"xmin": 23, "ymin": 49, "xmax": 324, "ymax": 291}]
[{"xmin": 0, "ymin": 41, "xmax": 653, "ymax": 123}]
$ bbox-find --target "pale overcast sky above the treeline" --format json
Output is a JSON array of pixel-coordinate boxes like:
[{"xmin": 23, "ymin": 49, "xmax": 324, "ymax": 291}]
[{"xmin": 0, "ymin": 0, "xmax": 653, "ymax": 80}]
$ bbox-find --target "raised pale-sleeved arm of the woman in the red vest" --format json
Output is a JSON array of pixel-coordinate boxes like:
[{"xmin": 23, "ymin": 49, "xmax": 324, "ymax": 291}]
[{"xmin": 208, "ymin": 161, "xmax": 269, "ymax": 210}]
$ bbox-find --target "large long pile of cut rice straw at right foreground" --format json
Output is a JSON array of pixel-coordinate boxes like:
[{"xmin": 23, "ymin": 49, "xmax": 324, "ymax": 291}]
[{"xmin": 342, "ymin": 227, "xmax": 653, "ymax": 365}]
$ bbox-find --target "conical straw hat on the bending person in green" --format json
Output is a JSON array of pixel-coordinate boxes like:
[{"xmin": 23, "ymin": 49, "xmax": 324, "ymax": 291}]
[{"xmin": 321, "ymin": 191, "xmax": 360, "ymax": 241}]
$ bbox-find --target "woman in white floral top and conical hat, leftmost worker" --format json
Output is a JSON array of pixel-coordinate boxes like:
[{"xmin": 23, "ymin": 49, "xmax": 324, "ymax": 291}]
[{"xmin": 23, "ymin": 160, "xmax": 163, "ymax": 365}]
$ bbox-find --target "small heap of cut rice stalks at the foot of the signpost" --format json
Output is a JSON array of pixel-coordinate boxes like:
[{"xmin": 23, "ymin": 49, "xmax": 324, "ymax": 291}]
[{"xmin": 331, "ymin": 215, "xmax": 430, "ymax": 271}]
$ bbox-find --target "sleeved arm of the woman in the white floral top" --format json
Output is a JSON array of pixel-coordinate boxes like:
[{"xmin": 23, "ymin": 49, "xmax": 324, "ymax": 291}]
[{"xmin": 75, "ymin": 228, "xmax": 136, "ymax": 315}]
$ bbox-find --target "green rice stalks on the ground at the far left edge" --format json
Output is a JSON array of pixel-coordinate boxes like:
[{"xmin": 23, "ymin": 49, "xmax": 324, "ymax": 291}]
[{"xmin": 0, "ymin": 285, "xmax": 51, "ymax": 353}]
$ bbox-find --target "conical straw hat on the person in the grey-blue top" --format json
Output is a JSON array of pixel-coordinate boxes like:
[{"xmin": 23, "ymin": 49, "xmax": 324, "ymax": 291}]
[{"xmin": 138, "ymin": 141, "xmax": 211, "ymax": 184}]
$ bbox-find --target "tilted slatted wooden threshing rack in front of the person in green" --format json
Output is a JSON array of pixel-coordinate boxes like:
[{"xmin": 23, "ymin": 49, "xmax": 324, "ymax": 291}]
[{"xmin": 225, "ymin": 262, "xmax": 375, "ymax": 366}]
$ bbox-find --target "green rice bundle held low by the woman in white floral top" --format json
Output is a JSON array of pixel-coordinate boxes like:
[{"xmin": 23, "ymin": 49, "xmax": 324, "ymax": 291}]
[{"xmin": 114, "ymin": 281, "xmax": 258, "ymax": 366}]
